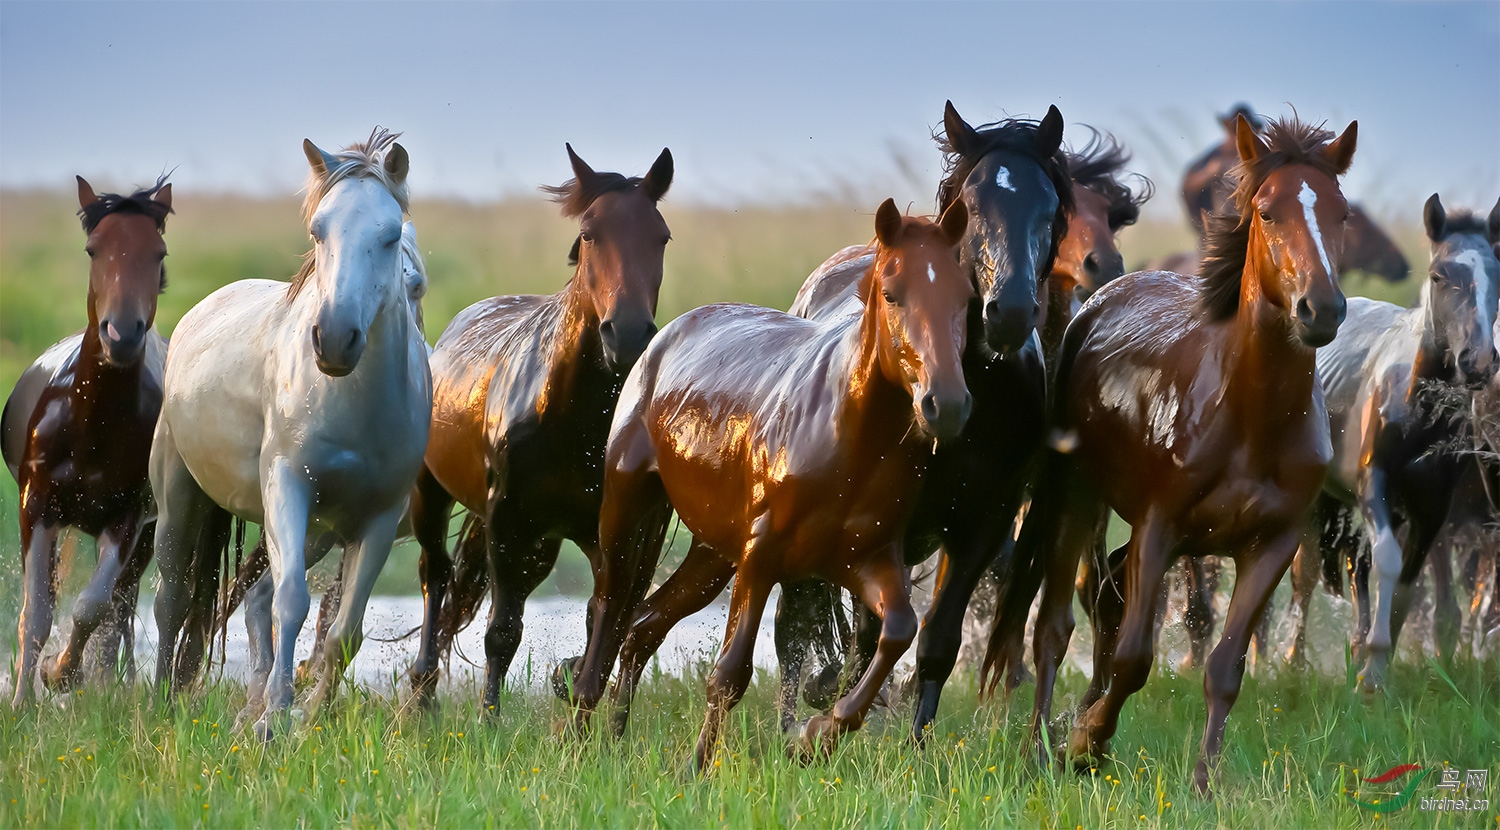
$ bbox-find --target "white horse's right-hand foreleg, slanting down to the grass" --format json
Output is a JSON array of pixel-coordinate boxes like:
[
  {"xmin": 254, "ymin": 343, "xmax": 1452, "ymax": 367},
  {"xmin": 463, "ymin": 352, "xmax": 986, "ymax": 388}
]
[{"xmin": 308, "ymin": 506, "xmax": 402, "ymax": 713}]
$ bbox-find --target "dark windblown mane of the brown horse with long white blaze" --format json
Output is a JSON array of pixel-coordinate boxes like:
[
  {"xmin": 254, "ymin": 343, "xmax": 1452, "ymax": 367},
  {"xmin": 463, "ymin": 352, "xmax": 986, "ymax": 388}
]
[{"xmin": 1202, "ymin": 117, "xmax": 1338, "ymax": 320}]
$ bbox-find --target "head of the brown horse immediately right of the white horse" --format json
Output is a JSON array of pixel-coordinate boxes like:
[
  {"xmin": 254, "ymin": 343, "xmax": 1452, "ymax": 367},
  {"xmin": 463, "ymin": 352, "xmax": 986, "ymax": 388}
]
[{"xmin": 543, "ymin": 144, "xmax": 672, "ymax": 374}]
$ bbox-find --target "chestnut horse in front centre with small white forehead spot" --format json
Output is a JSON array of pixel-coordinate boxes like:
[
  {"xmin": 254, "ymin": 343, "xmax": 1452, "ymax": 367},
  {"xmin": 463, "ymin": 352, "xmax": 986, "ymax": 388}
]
[{"xmin": 575, "ymin": 200, "xmax": 978, "ymax": 771}]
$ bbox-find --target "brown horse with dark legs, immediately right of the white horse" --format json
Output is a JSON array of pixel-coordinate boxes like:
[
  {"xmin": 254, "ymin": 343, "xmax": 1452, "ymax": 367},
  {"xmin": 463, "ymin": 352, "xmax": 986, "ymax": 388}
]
[{"xmin": 411, "ymin": 146, "xmax": 672, "ymax": 711}]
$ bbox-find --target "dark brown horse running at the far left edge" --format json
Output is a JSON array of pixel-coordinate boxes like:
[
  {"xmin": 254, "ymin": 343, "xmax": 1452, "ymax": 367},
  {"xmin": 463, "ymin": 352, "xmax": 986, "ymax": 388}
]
[{"xmin": 0, "ymin": 176, "xmax": 173, "ymax": 705}]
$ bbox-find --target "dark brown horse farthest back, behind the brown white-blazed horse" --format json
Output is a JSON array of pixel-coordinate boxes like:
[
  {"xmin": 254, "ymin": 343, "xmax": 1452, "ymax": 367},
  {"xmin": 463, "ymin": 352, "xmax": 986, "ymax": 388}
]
[{"xmin": 1163, "ymin": 104, "xmax": 1412, "ymax": 282}]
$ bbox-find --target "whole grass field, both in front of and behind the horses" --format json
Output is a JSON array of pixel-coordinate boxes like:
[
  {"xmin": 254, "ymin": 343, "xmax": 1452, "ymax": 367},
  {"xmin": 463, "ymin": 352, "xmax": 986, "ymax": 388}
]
[{"xmin": 0, "ymin": 192, "xmax": 1482, "ymax": 827}]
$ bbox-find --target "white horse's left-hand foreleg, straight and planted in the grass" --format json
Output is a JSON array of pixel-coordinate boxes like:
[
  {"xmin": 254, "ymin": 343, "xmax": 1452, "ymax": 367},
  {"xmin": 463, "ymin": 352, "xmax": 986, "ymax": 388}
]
[{"xmin": 255, "ymin": 458, "xmax": 312, "ymax": 740}]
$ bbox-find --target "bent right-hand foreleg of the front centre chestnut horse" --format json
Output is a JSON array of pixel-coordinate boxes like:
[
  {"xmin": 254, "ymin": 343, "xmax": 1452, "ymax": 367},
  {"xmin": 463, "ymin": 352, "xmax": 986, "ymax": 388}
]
[{"xmin": 798, "ymin": 543, "xmax": 912, "ymax": 759}]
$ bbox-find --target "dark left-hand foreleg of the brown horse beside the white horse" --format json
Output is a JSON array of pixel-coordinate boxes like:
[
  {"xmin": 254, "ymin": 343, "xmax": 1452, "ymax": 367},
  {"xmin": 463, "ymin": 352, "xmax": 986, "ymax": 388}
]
[{"xmin": 411, "ymin": 465, "xmax": 453, "ymax": 705}]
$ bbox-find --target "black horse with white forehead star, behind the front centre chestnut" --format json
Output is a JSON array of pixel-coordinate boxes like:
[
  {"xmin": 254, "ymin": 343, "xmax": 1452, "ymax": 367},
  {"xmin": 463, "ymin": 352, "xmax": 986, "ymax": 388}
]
[{"xmin": 756, "ymin": 102, "xmax": 1074, "ymax": 740}]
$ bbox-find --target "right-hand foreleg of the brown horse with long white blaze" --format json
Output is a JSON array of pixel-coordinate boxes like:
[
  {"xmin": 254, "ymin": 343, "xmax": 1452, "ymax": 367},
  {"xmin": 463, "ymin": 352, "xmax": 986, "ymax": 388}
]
[{"xmin": 1193, "ymin": 530, "xmax": 1299, "ymax": 794}]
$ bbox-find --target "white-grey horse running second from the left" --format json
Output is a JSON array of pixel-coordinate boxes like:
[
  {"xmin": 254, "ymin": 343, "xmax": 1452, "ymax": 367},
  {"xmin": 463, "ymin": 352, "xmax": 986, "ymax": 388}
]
[{"xmin": 152, "ymin": 128, "xmax": 432, "ymax": 738}]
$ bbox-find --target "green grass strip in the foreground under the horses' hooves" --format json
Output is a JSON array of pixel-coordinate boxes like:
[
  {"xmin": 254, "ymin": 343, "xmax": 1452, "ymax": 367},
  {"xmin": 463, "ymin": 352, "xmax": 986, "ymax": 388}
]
[{"xmin": 0, "ymin": 654, "xmax": 1500, "ymax": 828}]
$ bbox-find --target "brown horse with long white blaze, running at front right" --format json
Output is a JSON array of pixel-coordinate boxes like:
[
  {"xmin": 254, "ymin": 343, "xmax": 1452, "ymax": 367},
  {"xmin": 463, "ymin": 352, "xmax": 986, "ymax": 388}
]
[{"xmin": 992, "ymin": 119, "xmax": 1358, "ymax": 794}]
